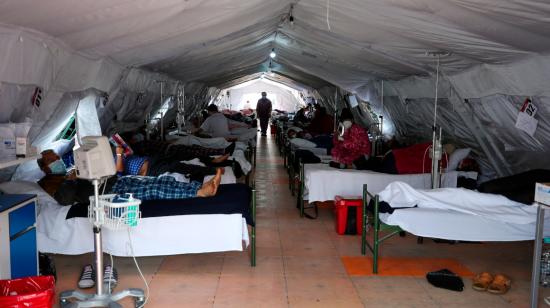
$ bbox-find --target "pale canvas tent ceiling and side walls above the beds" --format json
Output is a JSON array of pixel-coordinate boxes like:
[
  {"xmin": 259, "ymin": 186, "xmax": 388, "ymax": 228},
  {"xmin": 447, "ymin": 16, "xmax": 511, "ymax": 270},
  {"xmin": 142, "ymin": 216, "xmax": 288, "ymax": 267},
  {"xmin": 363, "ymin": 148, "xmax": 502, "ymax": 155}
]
[{"xmin": 0, "ymin": 0, "xmax": 550, "ymax": 180}]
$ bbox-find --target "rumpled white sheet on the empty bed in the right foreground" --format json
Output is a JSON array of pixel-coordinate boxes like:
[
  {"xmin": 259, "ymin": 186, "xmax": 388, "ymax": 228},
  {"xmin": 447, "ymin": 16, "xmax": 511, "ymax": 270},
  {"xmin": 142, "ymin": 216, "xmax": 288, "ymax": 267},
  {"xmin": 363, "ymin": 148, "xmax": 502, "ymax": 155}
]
[{"xmin": 380, "ymin": 182, "xmax": 550, "ymax": 241}]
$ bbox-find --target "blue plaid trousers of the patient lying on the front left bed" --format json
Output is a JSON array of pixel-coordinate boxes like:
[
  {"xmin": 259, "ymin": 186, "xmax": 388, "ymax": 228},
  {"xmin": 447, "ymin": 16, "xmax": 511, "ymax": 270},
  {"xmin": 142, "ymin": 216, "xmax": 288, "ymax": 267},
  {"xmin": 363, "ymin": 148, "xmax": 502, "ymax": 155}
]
[{"xmin": 112, "ymin": 176, "xmax": 202, "ymax": 201}]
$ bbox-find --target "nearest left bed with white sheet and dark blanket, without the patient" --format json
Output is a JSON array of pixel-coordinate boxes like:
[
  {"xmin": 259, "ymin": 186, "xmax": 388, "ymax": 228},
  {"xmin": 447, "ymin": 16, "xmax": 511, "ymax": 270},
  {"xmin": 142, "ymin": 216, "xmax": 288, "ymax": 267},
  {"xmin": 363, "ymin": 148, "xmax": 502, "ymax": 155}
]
[{"xmin": 0, "ymin": 177, "xmax": 256, "ymax": 266}]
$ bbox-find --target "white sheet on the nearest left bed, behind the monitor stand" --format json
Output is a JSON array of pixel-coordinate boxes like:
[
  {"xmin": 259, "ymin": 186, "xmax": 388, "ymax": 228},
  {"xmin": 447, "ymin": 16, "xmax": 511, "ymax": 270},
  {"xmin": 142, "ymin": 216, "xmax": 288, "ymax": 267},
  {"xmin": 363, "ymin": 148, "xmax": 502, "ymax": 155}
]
[{"xmin": 0, "ymin": 181, "xmax": 249, "ymax": 256}]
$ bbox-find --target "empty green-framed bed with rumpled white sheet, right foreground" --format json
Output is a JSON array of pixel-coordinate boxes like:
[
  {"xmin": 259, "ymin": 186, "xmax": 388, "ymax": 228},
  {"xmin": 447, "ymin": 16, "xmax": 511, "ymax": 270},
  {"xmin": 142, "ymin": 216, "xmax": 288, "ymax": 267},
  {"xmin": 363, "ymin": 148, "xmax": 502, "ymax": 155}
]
[{"xmin": 361, "ymin": 182, "xmax": 550, "ymax": 273}]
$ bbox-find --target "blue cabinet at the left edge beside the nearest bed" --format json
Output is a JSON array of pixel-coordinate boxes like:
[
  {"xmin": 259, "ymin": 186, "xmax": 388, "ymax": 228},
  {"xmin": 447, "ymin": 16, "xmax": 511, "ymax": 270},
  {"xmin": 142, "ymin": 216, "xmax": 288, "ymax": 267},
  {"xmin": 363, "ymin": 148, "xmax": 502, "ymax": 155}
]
[{"xmin": 0, "ymin": 195, "xmax": 38, "ymax": 279}]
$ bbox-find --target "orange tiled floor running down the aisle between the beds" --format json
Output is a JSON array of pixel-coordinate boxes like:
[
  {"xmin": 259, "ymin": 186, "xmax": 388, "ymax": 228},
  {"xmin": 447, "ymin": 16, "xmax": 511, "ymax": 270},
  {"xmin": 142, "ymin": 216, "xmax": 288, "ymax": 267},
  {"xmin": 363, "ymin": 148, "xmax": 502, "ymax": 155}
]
[{"xmin": 50, "ymin": 137, "xmax": 550, "ymax": 308}]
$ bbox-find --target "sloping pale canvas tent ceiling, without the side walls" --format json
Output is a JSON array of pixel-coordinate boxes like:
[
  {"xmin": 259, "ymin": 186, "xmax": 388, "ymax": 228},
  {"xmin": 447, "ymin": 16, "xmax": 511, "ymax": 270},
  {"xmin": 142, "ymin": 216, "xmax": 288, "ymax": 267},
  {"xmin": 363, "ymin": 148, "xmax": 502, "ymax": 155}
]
[{"xmin": 0, "ymin": 0, "xmax": 550, "ymax": 91}]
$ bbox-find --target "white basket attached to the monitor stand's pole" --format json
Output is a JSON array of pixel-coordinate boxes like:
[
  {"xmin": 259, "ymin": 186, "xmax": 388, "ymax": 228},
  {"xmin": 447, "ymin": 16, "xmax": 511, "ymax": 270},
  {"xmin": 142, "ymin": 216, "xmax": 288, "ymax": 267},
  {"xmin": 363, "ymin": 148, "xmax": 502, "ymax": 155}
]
[{"xmin": 88, "ymin": 194, "xmax": 141, "ymax": 230}]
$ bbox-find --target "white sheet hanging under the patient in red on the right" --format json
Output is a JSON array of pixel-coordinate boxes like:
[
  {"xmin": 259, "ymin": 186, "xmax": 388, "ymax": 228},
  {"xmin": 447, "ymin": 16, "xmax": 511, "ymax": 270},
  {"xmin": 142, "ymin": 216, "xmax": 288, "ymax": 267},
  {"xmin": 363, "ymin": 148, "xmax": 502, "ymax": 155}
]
[{"xmin": 304, "ymin": 164, "xmax": 477, "ymax": 202}]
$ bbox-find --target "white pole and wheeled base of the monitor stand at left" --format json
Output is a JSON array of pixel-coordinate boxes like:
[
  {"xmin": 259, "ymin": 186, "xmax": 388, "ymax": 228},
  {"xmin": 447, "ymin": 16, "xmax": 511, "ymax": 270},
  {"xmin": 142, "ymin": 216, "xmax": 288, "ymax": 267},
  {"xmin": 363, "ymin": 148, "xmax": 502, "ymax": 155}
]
[{"xmin": 59, "ymin": 179, "xmax": 145, "ymax": 308}]
